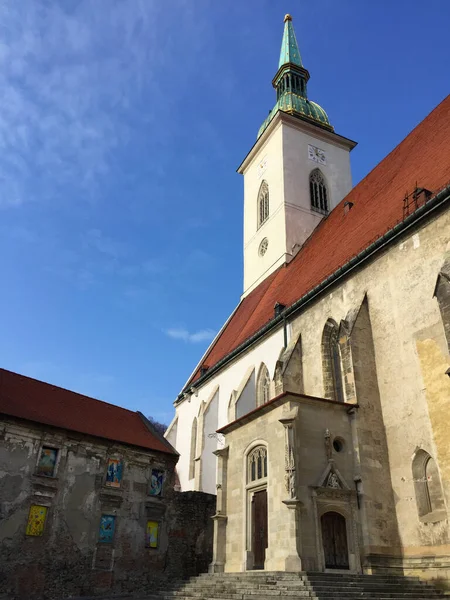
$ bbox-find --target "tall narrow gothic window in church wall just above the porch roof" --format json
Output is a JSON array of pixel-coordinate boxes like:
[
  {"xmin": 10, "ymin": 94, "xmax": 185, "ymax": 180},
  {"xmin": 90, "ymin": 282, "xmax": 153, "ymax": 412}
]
[{"xmin": 322, "ymin": 319, "xmax": 344, "ymax": 402}]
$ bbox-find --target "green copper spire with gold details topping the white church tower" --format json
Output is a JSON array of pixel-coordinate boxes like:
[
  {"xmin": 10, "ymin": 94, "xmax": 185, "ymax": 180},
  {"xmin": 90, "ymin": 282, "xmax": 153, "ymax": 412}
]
[{"xmin": 258, "ymin": 15, "xmax": 333, "ymax": 138}]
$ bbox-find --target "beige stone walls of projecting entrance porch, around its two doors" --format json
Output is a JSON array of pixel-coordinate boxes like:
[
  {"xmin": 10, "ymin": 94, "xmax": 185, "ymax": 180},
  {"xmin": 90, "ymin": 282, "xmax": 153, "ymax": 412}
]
[{"xmin": 218, "ymin": 396, "xmax": 360, "ymax": 572}]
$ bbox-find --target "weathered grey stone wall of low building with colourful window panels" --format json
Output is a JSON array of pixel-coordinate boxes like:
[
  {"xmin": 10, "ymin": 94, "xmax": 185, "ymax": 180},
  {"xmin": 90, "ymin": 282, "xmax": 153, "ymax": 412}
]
[{"xmin": 0, "ymin": 419, "xmax": 215, "ymax": 600}]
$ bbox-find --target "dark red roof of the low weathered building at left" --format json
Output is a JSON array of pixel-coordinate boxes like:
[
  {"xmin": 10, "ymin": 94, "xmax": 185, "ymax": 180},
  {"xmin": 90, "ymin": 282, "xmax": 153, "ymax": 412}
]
[{"xmin": 0, "ymin": 369, "xmax": 176, "ymax": 454}]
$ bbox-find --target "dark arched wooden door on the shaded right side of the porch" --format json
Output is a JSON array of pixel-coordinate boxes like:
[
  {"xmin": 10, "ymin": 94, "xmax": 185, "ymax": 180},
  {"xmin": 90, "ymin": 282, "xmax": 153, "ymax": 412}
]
[{"xmin": 320, "ymin": 512, "xmax": 349, "ymax": 569}]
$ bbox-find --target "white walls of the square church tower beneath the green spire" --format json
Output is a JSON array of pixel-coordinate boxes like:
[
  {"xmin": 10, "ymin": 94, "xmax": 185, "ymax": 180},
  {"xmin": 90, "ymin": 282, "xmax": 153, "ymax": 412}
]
[{"xmin": 239, "ymin": 111, "xmax": 355, "ymax": 296}]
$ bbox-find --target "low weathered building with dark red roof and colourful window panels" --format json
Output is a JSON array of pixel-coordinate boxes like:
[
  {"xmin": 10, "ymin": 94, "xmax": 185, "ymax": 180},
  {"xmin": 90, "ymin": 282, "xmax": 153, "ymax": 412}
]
[{"xmin": 0, "ymin": 369, "xmax": 215, "ymax": 600}]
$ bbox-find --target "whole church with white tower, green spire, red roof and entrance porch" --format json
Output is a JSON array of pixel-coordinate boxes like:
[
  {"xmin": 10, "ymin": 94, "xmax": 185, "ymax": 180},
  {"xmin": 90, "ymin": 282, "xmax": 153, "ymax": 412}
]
[{"xmin": 166, "ymin": 15, "xmax": 450, "ymax": 584}]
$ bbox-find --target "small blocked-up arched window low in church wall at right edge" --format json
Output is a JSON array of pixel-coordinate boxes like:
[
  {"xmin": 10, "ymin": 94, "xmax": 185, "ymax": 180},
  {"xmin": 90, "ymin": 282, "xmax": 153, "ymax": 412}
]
[{"xmin": 412, "ymin": 450, "xmax": 445, "ymax": 521}]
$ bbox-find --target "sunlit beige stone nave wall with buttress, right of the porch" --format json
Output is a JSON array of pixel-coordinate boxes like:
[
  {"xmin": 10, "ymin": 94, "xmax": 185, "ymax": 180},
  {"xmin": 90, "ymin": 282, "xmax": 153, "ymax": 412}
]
[{"xmin": 284, "ymin": 213, "xmax": 450, "ymax": 562}]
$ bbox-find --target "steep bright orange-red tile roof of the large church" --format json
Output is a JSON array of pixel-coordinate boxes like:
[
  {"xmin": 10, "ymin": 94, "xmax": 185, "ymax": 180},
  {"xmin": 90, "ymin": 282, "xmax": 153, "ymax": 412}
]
[{"xmin": 190, "ymin": 96, "xmax": 450, "ymax": 382}]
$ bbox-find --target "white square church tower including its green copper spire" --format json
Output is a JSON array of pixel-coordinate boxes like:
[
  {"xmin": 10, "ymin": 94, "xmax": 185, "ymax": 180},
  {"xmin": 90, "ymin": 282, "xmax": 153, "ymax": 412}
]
[{"xmin": 238, "ymin": 15, "xmax": 356, "ymax": 296}]
